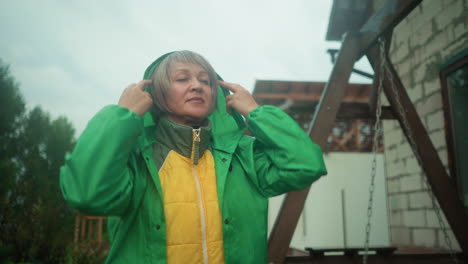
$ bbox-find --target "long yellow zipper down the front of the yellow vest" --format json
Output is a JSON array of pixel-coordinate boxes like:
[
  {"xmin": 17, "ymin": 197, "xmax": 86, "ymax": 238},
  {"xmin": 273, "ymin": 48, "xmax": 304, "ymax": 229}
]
[{"xmin": 192, "ymin": 128, "xmax": 208, "ymax": 264}]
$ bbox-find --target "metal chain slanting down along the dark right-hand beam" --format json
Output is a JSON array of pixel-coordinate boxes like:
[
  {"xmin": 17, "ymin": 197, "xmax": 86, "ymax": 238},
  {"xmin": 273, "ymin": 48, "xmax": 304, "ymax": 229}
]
[{"xmin": 379, "ymin": 39, "xmax": 458, "ymax": 264}]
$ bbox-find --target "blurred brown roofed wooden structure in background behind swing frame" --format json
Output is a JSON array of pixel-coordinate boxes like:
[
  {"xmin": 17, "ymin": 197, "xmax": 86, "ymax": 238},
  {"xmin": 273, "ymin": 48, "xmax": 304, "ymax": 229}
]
[{"xmin": 252, "ymin": 80, "xmax": 386, "ymax": 154}]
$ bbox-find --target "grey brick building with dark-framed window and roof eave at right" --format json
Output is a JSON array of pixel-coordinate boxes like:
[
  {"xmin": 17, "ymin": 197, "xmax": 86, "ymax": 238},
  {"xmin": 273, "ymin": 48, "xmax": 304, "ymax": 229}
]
[{"xmin": 327, "ymin": 0, "xmax": 468, "ymax": 253}]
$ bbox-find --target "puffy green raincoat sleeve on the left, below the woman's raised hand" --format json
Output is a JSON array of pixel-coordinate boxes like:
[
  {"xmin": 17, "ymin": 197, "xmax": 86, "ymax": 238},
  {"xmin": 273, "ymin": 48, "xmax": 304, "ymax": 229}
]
[{"xmin": 60, "ymin": 105, "xmax": 143, "ymax": 215}]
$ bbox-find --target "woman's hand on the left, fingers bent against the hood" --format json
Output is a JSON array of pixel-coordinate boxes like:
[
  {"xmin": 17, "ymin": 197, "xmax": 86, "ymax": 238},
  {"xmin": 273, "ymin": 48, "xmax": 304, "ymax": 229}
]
[{"xmin": 118, "ymin": 80, "xmax": 153, "ymax": 116}]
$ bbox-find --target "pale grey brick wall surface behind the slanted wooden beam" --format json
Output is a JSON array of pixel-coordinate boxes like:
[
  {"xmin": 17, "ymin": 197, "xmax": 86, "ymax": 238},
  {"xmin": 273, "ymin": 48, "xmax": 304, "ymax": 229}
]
[{"xmin": 382, "ymin": 0, "xmax": 468, "ymax": 252}]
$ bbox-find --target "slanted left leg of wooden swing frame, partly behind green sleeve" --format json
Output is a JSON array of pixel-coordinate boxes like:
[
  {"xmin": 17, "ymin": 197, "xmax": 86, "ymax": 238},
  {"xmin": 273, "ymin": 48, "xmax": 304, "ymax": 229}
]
[{"xmin": 268, "ymin": 34, "xmax": 360, "ymax": 263}]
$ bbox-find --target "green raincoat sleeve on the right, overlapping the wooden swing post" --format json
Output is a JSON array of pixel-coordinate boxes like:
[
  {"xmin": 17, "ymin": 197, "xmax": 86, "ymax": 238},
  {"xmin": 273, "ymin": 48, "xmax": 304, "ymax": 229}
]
[{"xmin": 247, "ymin": 106, "xmax": 327, "ymax": 197}]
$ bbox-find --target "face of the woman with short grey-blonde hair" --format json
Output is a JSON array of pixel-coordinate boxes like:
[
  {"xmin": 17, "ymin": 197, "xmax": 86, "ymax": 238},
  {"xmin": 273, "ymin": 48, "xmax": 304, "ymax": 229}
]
[{"xmin": 167, "ymin": 62, "xmax": 213, "ymax": 126}]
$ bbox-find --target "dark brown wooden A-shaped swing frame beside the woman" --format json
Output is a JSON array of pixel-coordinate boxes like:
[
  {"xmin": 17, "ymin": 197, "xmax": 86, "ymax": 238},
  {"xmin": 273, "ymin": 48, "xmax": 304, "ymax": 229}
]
[{"xmin": 268, "ymin": 0, "xmax": 468, "ymax": 263}]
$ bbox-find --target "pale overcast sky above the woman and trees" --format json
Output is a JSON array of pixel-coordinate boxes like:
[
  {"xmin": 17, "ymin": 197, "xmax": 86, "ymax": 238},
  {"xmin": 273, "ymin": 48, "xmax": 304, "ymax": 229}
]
[{"xmin": 0, "ymin": 0, "xmax": 370, "ymax": 134}]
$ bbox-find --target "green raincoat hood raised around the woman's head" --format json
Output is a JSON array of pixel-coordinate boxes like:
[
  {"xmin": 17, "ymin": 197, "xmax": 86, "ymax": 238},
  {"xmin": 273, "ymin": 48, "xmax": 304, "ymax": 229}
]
[{"xmin": 143, "ymin": 52, "xmax": 246, "ymax": 153}]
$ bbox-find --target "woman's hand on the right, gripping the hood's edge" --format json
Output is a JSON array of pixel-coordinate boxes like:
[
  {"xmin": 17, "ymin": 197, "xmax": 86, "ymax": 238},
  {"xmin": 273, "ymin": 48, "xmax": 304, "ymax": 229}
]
[{"xmin": 218, "ymin": 81, "xmax": 258, "ymax": 116}]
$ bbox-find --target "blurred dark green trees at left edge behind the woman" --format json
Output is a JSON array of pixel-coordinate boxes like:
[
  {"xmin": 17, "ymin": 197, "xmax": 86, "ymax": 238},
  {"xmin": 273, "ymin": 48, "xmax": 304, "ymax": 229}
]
[{"xmin": 0, "ymin": 60, "xmax": 102, "ymax": 263}]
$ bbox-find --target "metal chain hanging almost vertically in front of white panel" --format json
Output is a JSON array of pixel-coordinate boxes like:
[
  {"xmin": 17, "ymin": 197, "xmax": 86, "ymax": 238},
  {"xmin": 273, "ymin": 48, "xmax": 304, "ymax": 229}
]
[{"xmin": 362, "ymin": 37, "xmax": 385, "ymax": 264}]
